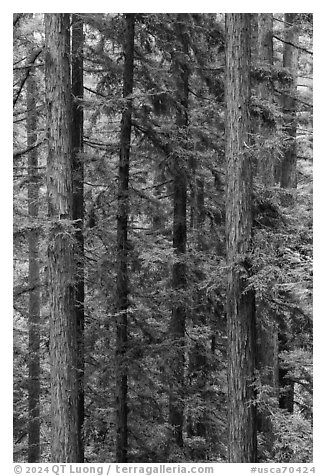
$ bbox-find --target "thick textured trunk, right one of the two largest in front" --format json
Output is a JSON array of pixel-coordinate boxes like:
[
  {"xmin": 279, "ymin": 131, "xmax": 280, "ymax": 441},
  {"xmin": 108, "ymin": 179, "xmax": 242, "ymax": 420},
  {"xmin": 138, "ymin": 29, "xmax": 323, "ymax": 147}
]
[{"xmin": 225, "ymin": 13, "xmax": 257, "ymax": 463}]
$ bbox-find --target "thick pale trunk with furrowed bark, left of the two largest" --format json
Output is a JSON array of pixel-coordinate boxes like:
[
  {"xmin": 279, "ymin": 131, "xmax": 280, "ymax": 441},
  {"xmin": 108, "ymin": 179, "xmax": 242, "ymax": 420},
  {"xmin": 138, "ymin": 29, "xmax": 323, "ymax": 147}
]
[{"xmin": 45, "ymin": 13, "xmax": 80, "ymax": 463}]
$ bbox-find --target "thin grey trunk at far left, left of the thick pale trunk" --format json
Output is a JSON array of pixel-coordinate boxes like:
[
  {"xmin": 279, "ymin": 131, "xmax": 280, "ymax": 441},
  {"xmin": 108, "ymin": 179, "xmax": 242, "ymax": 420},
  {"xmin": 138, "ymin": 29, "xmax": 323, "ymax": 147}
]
[{"xmin": 26, "ymin": 61, "xmax": 40, "ymax": 463}]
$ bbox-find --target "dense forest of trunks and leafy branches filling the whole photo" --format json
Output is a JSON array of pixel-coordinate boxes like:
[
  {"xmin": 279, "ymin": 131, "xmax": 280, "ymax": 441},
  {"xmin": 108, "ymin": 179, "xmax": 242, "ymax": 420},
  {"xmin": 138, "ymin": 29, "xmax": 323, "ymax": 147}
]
[{"xmin": 13, "ymin": 13, "xmax": 313, "ymax": 463}]
